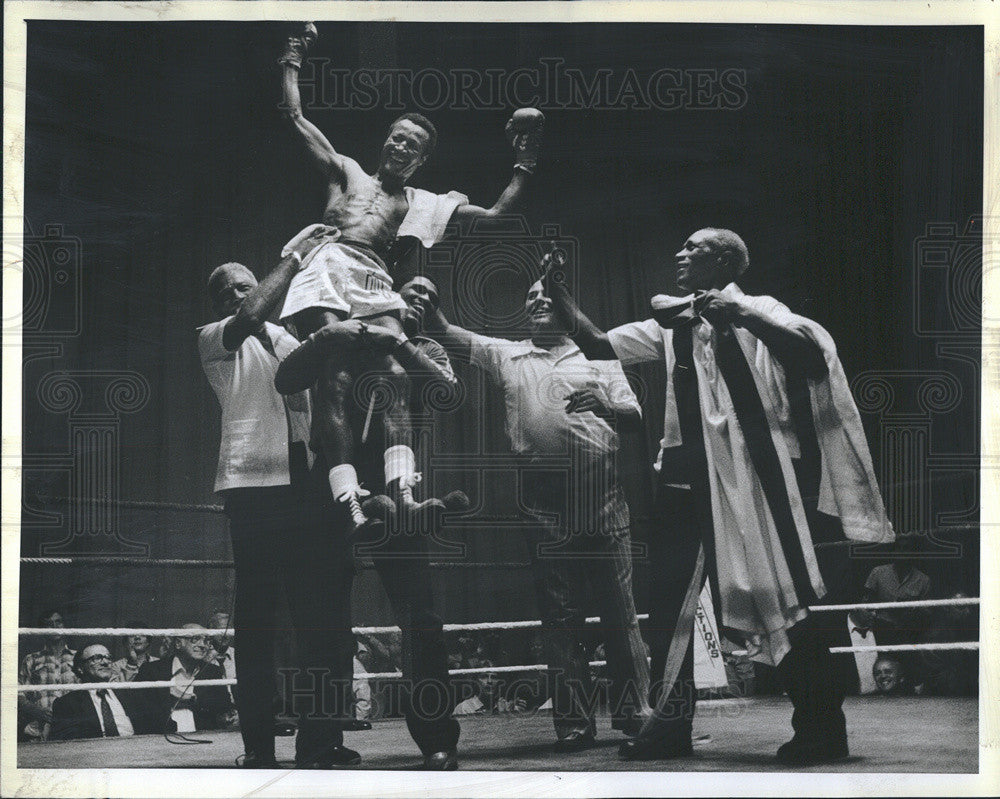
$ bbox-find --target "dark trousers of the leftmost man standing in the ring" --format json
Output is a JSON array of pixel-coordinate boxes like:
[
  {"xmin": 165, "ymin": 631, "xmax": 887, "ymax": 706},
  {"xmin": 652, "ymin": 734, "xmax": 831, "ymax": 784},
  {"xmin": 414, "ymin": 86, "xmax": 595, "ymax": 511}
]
[{"xmin": 226, "ymin": 475, "xmax": 354, "ymax": 760}]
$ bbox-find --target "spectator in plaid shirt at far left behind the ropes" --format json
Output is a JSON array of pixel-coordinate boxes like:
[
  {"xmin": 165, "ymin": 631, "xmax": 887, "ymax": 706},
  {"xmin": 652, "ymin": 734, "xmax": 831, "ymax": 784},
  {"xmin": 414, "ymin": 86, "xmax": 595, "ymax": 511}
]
[{"xmin": 17, "ymin": 610, "xmax": 76, "ymax": 740}]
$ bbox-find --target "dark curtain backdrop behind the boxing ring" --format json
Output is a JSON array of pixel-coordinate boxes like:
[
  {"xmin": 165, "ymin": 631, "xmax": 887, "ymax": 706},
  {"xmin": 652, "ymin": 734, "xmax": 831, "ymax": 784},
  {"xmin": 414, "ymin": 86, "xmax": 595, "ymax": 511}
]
[{"xmin": 21, "ymin": 22, "xmax": 983, "ymax": 648}]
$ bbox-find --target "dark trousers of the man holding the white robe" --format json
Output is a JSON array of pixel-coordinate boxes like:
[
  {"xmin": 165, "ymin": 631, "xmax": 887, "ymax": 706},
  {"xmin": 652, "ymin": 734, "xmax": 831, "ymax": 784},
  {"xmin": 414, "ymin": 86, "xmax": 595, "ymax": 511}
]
[{"xmin": 646, "ymin": 486, "xmax": 847, "ymax": 744}]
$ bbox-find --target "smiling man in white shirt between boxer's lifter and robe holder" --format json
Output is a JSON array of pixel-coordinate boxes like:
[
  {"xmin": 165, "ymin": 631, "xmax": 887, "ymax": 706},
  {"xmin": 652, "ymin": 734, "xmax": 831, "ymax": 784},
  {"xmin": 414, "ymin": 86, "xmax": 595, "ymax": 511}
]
[{"xmin": 423, "ymin": 283, "xmax": 649, "ymax": 752}]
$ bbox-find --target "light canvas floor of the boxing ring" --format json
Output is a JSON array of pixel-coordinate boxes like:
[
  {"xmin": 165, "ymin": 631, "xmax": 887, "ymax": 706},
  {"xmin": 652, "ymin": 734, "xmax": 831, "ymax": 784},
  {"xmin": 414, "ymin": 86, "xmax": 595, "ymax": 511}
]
[{"xmin": 17, "ymin": 697, "xmax": 979, "ymax": 773}]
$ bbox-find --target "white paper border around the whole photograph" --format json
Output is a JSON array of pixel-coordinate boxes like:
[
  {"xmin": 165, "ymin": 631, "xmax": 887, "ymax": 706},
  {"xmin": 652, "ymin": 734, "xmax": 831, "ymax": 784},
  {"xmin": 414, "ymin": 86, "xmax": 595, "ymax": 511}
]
[{"xmin": 0, "ymin": 0, "xmax": 1000, "ymax": 797}]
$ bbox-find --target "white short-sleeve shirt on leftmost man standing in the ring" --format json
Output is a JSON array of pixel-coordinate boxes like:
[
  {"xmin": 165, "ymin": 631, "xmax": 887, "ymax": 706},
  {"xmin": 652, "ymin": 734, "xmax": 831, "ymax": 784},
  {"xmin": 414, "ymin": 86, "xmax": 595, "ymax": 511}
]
[{"xmin": 198, "ymin": 317, "xmax": 309, "ymax": 491}]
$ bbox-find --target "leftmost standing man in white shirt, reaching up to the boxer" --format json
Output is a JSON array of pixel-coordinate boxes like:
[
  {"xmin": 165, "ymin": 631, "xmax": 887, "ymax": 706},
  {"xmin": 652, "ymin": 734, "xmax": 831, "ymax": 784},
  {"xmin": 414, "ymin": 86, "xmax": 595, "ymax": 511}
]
[{"xmin": 199, "ymin": 230, "xmax": 361, "ymax": 768}]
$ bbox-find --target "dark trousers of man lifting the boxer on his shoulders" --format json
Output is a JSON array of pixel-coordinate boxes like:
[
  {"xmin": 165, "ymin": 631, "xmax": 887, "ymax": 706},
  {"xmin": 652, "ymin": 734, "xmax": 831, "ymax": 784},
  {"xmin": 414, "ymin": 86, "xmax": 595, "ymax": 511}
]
[{"xmin": 372, "ymin": 534, "xmax": 459, "ymax": 756}]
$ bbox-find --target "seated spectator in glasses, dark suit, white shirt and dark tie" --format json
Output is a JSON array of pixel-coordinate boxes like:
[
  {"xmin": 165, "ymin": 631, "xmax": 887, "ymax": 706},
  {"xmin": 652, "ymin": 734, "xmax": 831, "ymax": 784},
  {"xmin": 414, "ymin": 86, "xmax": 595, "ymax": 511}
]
[{"xmin": 49, "ymin": 641, "xmax": 156, "ymax": 740}]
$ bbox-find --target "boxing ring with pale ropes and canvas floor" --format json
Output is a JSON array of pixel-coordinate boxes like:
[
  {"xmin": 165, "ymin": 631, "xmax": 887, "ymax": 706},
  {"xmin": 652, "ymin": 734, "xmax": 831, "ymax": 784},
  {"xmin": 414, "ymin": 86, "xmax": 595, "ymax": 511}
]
[{"xmin": 17, "ymin": 502, "xmax": 980, "ymax": 773}]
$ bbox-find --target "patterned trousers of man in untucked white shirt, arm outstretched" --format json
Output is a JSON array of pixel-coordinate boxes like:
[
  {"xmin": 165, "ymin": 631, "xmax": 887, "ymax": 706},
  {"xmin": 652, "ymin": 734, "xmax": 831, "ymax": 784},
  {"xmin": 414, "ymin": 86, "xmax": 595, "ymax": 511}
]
[{"xmin": 525, "ymin": 472, "xmax": 649, "ymax": 738}]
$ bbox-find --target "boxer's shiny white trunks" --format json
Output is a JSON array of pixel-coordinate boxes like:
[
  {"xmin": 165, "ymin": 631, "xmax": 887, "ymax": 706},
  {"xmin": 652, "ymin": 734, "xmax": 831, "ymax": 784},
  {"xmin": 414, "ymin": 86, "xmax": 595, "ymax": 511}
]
[{"xmin": 281, "ymin": 231, "xmax": 406, "ymax": 322}]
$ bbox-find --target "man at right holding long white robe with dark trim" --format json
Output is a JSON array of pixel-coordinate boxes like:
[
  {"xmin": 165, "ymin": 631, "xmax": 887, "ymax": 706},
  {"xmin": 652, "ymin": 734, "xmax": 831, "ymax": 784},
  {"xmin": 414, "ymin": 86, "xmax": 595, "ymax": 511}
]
[{"xmin": 546, "ymin": 228, "xmax": 893, "ymax": 765}]
